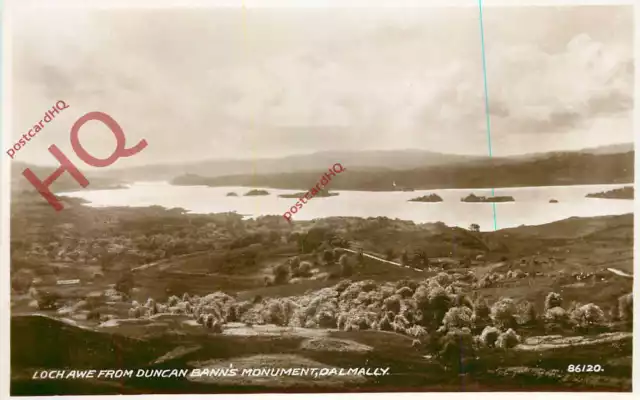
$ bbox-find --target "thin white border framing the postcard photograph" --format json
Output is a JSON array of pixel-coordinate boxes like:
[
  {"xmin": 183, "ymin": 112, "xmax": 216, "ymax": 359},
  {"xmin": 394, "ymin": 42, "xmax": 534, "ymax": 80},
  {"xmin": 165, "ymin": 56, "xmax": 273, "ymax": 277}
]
[{"xmin": 0, "ymin": 0, "xmax": 640, "ymax": 400}]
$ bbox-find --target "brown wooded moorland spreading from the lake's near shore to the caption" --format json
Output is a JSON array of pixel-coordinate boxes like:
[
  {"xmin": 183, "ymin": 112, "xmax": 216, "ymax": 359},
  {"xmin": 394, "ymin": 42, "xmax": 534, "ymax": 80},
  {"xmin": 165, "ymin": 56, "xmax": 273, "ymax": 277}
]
[{"xmin": 11, "ymin": 195, "xmax": 633, "ymax": 395}]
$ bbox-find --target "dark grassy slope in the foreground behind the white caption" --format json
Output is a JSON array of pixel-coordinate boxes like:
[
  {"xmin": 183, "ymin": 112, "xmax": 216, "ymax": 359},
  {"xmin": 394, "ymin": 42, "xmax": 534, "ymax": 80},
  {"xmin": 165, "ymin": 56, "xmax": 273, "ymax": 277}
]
[{"xmin": 12, "ymin": 316, "xmax": 631, "ymax": 395}]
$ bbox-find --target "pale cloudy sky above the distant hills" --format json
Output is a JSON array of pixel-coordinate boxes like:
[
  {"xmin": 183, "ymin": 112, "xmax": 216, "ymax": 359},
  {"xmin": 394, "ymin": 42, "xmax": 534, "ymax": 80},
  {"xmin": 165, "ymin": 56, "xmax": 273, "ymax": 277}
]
[{"xmin": 5, "ymin": 6, "xmax": 633, "ymax": 168}]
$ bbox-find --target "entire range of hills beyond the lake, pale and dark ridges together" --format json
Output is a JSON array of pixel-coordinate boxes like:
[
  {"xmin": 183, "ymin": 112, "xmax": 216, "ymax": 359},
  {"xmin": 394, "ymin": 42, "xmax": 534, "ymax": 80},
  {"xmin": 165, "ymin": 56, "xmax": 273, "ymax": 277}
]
[{"xmin": 11, "ymin": 143, "xmax": 634, "ymax": 191}]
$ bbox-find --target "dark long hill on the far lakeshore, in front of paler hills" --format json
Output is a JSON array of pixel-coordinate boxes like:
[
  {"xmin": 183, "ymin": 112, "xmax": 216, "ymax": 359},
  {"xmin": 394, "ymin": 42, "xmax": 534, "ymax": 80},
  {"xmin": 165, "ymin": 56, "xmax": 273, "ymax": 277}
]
[{"xmin": 172, "ymin": 152, "xmax": 634, "ymax": 191}]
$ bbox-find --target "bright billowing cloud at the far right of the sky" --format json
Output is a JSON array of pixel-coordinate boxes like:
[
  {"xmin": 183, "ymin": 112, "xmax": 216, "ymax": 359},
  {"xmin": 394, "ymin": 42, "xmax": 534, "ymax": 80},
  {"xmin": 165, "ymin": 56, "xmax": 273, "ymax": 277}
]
[{"xmin": 488, "ymin": 33, "xmax": 633, "ymax": 134}]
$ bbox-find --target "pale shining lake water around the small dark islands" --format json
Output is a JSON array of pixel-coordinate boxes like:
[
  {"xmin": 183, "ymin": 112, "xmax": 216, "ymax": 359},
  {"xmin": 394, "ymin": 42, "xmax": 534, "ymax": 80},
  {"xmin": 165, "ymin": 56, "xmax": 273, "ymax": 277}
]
[{"xmin": 59, "ymin": 182, "xmax": 634, "ymax": 231}]
